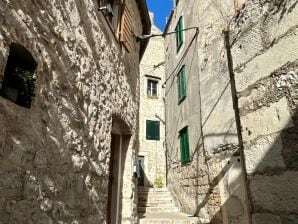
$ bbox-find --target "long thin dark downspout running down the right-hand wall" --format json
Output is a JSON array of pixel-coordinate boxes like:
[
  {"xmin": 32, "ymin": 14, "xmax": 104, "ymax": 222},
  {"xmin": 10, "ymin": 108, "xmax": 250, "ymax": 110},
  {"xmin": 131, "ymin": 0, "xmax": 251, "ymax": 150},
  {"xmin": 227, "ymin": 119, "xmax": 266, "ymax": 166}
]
[{"xmin": 223, "ymin": 28, "xmax": 252, "ymax": 223}]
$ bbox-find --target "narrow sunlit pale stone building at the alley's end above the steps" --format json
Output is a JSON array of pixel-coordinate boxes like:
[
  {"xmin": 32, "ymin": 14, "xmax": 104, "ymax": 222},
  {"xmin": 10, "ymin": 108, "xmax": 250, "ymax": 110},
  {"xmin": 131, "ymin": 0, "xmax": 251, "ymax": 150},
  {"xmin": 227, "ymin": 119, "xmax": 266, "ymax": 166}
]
[{"xmin": 139, "ymin": 13, "xmax": 166, "ymax": 187}]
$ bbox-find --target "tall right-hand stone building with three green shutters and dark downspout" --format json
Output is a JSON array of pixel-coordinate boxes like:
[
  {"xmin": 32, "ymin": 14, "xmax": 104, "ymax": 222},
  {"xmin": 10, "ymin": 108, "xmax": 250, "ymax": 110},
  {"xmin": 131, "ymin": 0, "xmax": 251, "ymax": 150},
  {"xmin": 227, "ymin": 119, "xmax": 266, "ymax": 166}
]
[{"xmin": 165, "ymin": 0, "xmax": 298, "ymax": 224}]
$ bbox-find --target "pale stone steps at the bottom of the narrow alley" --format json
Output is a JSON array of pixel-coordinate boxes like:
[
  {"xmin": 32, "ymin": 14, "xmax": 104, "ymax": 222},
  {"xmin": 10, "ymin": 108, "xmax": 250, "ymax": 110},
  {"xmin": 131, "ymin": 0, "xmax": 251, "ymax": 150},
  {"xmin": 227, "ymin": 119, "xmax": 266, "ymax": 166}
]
[{"xmin": 138, "ymin": 187, "xmax": 199, "ymax": 224}]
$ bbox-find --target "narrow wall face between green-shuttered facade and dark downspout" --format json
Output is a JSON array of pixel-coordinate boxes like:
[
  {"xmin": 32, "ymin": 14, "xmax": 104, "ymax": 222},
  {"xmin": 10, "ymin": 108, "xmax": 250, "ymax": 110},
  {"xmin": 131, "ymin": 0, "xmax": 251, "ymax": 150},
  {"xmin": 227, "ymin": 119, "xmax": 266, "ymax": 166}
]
[{"xmin": 198, "ymin": 0, "xmax": 249, "ymax": 224}]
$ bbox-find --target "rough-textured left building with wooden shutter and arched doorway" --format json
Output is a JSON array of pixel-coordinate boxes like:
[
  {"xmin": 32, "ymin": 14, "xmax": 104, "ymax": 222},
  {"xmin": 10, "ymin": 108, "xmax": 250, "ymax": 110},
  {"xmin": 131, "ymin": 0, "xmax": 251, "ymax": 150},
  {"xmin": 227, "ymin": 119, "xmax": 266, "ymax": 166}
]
[{"xmin": 0, "ymin": 0, "xmax": 151, "ymax": 224}]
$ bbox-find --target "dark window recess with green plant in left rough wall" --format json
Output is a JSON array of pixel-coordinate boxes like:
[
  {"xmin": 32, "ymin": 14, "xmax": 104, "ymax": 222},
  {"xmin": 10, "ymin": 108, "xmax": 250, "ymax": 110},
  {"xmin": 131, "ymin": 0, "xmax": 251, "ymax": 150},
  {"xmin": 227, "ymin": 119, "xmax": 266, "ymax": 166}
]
[{"xmin": 0, "ymin": 44, "xmax": 37, "ymax": 108}]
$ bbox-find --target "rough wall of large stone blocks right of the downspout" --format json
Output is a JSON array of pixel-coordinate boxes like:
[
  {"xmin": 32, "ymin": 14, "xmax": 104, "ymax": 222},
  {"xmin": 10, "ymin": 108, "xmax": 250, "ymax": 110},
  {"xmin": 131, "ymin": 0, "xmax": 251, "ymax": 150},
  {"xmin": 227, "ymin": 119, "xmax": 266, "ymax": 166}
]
[{"xmin": 231, "ymin": 0, "xmax": 298, "ymax": 224}]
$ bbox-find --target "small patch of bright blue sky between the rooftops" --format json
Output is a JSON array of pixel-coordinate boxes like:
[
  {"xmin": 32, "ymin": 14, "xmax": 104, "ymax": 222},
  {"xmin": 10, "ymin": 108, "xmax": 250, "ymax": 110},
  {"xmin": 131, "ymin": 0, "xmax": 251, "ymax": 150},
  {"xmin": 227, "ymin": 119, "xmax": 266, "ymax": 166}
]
[{"xmin": 147, "ymin": 0, "xmax": 173, "ymax": 31}]
